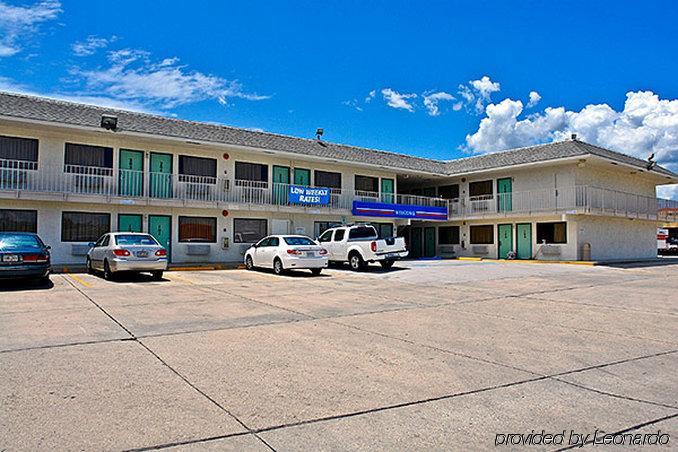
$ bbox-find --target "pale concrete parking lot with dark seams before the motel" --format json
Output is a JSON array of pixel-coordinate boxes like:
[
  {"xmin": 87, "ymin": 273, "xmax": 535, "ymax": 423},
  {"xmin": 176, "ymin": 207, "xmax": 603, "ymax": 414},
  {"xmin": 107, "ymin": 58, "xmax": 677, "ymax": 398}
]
[{"xmin": 0, "ymin": 261, "xmax": 678, "ymax": 450}]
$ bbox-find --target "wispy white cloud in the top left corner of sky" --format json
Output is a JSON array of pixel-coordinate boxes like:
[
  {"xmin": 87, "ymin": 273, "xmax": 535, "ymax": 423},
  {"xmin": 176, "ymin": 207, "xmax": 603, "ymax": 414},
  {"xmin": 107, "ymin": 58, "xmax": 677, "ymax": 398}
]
[{"xmin": 0, "ymin": 0, "xmax": 61, "ymax": 57}]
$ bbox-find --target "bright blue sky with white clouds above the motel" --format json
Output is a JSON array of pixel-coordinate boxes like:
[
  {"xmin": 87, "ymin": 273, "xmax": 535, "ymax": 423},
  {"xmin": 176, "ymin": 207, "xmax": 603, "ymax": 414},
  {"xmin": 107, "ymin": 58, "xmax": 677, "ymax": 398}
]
[{"xmin": 0, "ymin": 0, "xmax": 678, "ymax": 196}]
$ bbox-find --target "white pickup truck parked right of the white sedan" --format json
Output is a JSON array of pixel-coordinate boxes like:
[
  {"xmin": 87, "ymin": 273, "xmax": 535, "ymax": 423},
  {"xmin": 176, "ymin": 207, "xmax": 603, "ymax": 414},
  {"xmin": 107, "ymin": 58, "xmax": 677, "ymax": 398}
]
[{"xmin": 318, "ymin": 224, "xmax": 407, "ymax": 271}]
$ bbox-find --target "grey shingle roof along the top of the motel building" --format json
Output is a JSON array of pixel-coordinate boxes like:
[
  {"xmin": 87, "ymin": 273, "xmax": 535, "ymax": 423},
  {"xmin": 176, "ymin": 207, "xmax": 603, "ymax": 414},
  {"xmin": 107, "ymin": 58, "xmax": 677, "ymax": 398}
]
[{"xmin": 0, "ymin": 92, "xmax": 678, "ymax": 177}]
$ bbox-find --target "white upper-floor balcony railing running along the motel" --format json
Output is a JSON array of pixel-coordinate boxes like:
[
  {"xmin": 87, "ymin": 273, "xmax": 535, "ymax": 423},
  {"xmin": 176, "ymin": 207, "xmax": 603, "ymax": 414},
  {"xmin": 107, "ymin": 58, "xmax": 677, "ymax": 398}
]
[{"xmin": 0, "ymin": 159, "xmax": 678, "ymax": 221}]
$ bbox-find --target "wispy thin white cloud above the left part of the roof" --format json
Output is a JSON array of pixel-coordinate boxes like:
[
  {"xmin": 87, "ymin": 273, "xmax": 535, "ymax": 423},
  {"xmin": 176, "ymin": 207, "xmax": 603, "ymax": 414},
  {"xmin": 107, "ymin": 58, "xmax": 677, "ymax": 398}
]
[{"xmin": 71, "ymin": 49, "xmax": 269, "ymax": 109}]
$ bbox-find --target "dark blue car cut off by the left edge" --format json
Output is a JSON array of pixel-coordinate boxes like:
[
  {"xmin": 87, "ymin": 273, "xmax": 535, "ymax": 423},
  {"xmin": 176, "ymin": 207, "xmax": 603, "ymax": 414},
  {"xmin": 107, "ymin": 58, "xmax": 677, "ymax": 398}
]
[{"xmin": 0, "ymin": 232, "xmax": 52, "ymax": 281}]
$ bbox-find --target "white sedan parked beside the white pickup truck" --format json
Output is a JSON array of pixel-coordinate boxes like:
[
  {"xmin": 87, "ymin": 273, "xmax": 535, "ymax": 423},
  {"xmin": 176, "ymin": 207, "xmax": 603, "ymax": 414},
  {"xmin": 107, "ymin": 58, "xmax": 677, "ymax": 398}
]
[{"xmin": 245, "ymin": 235, "xmax": 327, "ymax": 275}]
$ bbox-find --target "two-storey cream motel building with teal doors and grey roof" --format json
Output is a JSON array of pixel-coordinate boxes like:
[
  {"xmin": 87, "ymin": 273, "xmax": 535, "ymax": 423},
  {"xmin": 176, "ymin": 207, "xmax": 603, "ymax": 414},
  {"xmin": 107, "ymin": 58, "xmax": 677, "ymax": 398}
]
[{"xmin": 0, "ymin": 93, "xmax": 678, "ymax": 265}]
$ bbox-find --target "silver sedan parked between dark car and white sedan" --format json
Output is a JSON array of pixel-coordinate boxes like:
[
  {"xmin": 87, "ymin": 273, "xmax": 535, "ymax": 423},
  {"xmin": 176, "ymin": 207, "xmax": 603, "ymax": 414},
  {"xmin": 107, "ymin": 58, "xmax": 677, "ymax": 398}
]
[{"xmin": 87, "ymin": 232, "xmax": 167, "ymax": 280}]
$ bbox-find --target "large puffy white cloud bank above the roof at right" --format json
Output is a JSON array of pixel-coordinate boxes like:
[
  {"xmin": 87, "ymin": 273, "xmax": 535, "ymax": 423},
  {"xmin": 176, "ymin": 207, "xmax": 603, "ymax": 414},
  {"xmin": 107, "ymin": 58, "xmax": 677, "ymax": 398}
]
[{"xmin": 465, "ymin": 91, "xmax": 678, "ymax": 184}]
